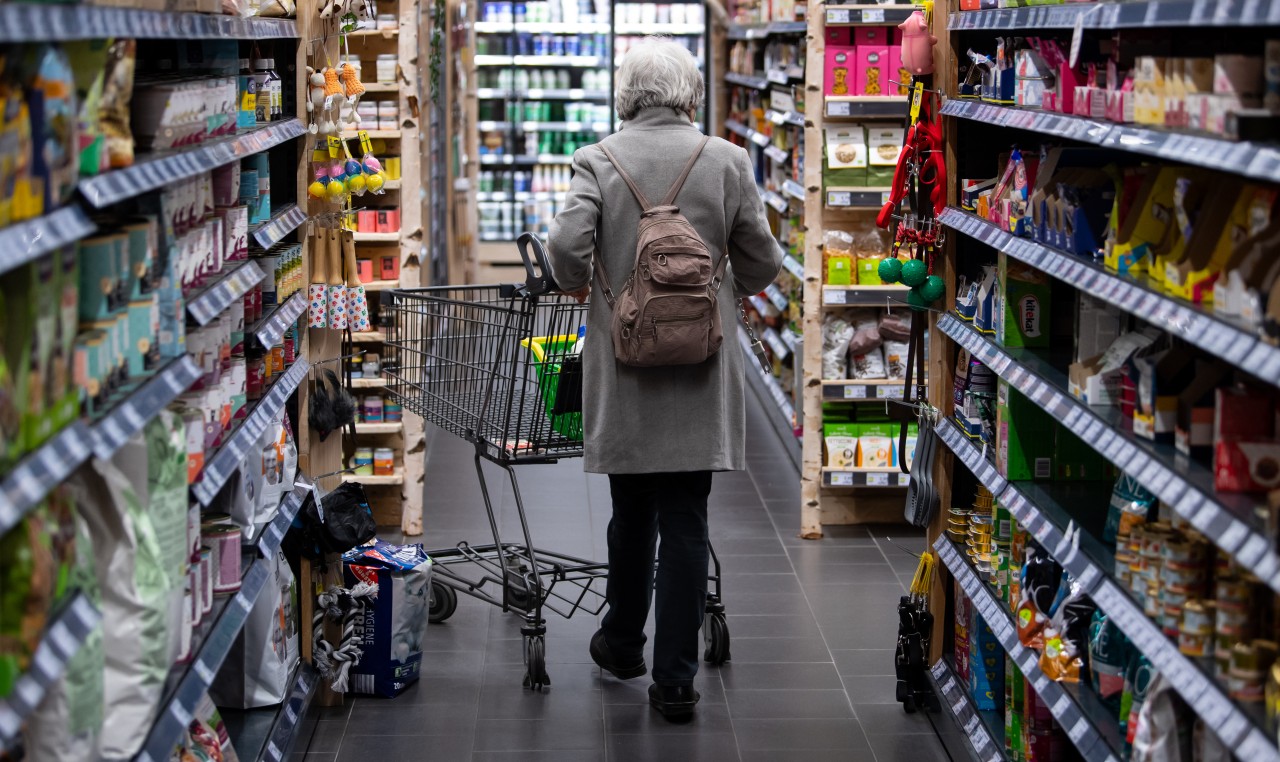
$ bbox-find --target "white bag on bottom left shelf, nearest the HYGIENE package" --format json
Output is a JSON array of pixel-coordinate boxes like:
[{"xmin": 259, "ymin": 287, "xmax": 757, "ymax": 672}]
[{"xmin": 209, "ymin": 551, "xmax": 298, "ymax": 709}]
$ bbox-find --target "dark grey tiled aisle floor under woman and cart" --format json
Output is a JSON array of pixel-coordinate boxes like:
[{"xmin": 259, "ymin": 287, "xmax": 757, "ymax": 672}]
[{"xmin": 296, "ymin": 394, "xmax": 947, "ymax": 762}]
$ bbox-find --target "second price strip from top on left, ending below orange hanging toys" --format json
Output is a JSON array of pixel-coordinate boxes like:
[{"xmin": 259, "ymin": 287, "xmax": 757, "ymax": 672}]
[{"xmin": 79, "ymin": 119, "xmax": 306, "ymax": 209}]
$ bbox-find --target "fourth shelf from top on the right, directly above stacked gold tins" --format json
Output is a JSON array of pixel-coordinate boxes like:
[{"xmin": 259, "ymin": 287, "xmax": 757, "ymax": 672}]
[{"xmin": 938, "ymin": 315, "xmax": 1280, "ymax": 592}]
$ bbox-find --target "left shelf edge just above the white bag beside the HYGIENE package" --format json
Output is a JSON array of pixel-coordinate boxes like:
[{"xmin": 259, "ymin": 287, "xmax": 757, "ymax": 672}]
[{"xmin": 137, "ymin": 484, "xmax": 311, "ymax": 762}]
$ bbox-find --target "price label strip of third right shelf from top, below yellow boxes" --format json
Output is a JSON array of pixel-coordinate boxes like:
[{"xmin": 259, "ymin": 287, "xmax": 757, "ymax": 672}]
[{"xmin": 938, "ymin": 207, "xmax": 1280, "ymax": 387}]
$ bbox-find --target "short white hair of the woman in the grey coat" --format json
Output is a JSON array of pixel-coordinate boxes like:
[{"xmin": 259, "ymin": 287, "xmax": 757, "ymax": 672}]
[{"xmin": 614, "ymin": 37, "xmax": 707, "ymax": 120}]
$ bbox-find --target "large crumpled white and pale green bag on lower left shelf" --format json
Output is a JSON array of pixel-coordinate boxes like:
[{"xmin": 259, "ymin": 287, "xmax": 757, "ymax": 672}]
[{"xmin": 68, "ymin": 411, "xmax": 189, "ymax": 758}]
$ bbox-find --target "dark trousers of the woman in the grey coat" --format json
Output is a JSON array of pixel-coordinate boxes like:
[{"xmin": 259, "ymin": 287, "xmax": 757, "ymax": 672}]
[{"xmin": 603, "ymin": 471, "xmax": 712, "ymax": 685}]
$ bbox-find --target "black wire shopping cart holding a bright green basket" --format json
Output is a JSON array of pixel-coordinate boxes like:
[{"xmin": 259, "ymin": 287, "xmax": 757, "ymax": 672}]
[{"xmin": 381, "ymin": 233, "xmax": 730, "ymax": 690}]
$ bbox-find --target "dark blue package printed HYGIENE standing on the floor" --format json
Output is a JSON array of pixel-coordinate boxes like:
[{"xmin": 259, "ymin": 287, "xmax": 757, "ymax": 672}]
[{"xmin": 342, "ymin": 539, "xmax": 431, "ymax": 698}]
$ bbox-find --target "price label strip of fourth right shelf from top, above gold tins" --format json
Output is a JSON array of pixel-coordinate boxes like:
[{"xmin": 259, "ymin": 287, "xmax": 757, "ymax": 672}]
[{"xmin": 938, "ymin": 315, "xmax": 1280, "ymax": 592}]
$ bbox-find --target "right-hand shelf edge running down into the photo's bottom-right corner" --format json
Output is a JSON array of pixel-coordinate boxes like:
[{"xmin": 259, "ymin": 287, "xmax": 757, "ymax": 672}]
[{"xmin": 938, "ymin": 421, "xmax": 1280, "ymax": 761}]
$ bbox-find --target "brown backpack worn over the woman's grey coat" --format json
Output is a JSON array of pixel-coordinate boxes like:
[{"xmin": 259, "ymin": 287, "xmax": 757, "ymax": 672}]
[{"xmin": 594, "ymin": 137, "xmax": 728, "ymax": 368}]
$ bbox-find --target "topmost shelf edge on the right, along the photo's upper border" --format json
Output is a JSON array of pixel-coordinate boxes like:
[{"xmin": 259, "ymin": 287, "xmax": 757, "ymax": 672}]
[{"xmin": 947, "ymin": 0, "xmax": 1280, "ymax": 32}]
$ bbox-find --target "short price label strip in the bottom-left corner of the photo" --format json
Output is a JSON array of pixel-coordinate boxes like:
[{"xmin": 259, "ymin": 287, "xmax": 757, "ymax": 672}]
[{"xmin": 0, "ymin": 593, "xmax": 102, "ymax": 753}]
